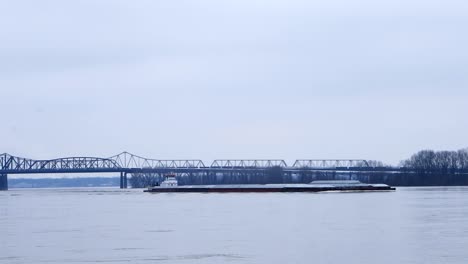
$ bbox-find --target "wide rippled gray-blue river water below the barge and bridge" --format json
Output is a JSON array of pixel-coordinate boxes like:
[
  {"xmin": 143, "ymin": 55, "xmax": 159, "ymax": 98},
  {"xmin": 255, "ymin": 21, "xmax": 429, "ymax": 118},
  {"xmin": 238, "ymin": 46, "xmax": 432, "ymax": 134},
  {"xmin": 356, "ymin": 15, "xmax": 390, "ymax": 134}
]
[{"xmin": 0, "ymin": 187, "xmax": 468, "ymax": 264}]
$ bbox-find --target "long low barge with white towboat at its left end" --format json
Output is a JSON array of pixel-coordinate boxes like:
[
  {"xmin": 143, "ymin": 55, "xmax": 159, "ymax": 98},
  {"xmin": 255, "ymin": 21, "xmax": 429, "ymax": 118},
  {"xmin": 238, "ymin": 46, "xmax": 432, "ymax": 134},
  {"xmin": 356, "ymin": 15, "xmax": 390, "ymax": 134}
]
[{"xmin": 144, "ymin": 175, "xmax": 395, "ymax": 193}]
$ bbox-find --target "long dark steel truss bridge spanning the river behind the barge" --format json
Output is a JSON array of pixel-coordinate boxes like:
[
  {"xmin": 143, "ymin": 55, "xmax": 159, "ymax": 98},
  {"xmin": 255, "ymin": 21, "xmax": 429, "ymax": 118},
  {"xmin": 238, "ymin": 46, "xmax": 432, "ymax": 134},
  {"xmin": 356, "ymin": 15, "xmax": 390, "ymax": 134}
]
[{"xmin": 0, "ymin": 152, "xmax": 400, "ymax": 190}]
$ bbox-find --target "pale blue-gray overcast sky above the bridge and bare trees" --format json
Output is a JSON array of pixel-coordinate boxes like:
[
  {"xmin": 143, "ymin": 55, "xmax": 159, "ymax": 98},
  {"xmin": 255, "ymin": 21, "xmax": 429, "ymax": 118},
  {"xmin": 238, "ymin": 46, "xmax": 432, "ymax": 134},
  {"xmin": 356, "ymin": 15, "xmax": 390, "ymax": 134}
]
[{"xmin": 0, "ymin": 0, "xmax": 468, "ymax": 164}]
